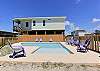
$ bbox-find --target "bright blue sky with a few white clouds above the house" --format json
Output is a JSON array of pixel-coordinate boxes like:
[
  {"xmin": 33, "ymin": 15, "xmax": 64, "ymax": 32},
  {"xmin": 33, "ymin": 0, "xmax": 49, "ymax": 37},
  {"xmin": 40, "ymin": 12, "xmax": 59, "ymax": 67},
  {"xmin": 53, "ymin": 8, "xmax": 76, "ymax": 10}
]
[{"xmin": 0, "ymin": 0, "xmax": 100, "ymax": 32}]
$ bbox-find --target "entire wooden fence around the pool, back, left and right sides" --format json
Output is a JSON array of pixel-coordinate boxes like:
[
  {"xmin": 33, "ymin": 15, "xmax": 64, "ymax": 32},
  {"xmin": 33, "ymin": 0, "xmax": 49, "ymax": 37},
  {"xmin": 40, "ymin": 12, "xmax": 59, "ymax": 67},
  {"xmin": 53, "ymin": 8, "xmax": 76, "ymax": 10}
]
[{"xmin": 0, "ymin": 34, "xmax": 100, "ymax": 53}]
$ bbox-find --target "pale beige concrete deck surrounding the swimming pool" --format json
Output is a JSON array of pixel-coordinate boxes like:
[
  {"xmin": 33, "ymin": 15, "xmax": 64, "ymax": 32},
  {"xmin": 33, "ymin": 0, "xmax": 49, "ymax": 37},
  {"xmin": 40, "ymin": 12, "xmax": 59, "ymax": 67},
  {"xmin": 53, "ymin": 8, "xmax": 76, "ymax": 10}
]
[{"xmin": 0, "ymin": 42, "xmax": 100, "ymax": 63}]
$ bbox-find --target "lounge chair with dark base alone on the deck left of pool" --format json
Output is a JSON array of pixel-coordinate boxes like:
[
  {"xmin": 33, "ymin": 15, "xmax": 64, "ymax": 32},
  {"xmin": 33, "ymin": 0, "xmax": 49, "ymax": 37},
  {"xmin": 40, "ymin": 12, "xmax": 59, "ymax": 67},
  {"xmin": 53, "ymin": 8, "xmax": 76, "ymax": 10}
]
[{"xmin": 8, "ymin": 40, "xmax": 26, "ymax": 58}]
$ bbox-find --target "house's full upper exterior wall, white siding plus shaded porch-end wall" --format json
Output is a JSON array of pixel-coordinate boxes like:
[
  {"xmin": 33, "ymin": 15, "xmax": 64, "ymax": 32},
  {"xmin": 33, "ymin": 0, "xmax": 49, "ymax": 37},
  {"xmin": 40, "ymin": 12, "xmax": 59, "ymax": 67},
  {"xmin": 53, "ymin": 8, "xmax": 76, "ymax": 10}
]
[{"xmin": 14, "ymin": 17, "xmax": 65, "ymax": 31}]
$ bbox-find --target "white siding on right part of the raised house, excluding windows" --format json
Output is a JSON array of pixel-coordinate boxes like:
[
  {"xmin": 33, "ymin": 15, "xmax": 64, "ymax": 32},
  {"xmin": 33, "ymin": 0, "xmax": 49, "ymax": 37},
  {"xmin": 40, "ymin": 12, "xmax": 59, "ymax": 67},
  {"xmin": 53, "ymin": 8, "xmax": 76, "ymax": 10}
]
[{"xmin": 32, "ymin": 18, "xmax": 65, "ymax": 30}]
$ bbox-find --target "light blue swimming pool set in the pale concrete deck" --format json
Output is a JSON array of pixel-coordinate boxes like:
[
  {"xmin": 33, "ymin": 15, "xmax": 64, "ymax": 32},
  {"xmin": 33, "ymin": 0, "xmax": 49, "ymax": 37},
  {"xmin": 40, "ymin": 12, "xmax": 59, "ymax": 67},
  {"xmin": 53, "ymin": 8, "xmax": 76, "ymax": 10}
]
[{"xmin": 21, "ymin": 42, "xmax": 69, "ymax": 54}]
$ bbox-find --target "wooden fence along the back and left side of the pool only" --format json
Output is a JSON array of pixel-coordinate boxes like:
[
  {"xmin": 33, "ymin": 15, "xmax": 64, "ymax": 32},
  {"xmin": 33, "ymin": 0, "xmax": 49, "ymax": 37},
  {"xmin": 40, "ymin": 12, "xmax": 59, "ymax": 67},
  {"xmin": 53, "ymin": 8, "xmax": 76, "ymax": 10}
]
[{"xmin": 0, "ymin": 35, "xmax": 64, "ymax": 46}]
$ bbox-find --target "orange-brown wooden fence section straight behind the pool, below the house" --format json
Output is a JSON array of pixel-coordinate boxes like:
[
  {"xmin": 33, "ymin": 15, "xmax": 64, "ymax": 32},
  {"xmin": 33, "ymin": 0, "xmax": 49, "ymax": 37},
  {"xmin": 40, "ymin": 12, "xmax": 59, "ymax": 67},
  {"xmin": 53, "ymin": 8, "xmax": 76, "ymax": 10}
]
[{"xmin": 18, "ymin": 35, "xmax": 64, "ymax": 42}]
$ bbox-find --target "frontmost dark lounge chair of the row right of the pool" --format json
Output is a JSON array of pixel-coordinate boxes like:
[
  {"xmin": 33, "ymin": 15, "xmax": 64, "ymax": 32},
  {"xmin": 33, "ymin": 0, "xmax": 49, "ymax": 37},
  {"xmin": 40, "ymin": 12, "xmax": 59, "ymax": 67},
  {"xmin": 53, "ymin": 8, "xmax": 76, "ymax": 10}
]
[{"xmin": 77, "ymin": 39, "xmax": 90, "ymax": 52}]
